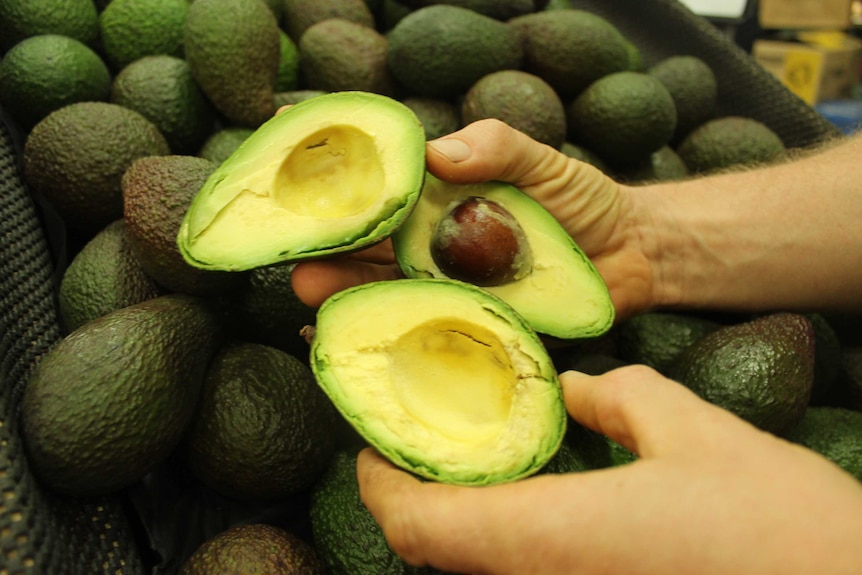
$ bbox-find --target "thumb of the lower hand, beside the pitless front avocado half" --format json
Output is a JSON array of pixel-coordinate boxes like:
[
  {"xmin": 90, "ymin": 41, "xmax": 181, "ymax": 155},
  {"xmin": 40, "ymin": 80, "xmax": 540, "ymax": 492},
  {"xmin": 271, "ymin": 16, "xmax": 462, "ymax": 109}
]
[{"xmin": 560, "ymin": 365, "xmax": 749, "ymax": 458}]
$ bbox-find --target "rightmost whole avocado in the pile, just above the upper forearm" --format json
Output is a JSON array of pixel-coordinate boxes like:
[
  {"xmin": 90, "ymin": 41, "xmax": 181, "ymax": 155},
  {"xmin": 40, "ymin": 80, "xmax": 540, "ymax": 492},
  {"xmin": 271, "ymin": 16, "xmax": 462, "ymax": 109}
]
[{"xmin": 676, "ymin": 116, "xmax": 786, "ymax": 174}]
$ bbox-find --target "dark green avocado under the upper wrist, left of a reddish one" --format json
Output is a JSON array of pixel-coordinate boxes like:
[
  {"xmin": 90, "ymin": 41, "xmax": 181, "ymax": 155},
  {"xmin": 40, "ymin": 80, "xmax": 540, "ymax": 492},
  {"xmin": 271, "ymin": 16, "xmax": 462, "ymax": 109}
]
[{"xmin": 618, "ymin": 311, "xmax": 721, "ymax": 375}]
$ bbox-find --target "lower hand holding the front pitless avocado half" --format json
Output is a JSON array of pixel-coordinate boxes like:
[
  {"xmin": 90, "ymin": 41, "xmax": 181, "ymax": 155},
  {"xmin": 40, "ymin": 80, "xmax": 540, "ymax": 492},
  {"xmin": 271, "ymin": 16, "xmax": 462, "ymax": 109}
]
[{"xmin": 357, "ymin": 366, "xmax": 862, "ymax": 575}]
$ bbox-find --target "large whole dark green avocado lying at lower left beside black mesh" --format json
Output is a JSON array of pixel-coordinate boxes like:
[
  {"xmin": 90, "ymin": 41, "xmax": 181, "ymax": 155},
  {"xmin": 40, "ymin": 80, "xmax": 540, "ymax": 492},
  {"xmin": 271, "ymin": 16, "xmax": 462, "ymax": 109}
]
[{"xmin": 21, "ymin": 294, "xmax": 222, "ymax": 496}]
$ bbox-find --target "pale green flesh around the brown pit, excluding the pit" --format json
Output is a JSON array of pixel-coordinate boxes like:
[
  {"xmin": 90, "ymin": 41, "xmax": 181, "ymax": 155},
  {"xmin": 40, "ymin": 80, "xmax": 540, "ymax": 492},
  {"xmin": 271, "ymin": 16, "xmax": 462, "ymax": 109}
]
[{"xmin": 392, "ymin": 174, "xmax": 614, "ymax": 339}]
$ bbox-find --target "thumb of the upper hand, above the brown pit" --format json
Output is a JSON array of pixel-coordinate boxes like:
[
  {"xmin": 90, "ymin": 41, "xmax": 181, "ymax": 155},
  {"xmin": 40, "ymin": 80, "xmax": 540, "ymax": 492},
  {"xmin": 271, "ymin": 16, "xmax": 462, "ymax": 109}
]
[{"xmin": 426, "ymin": 119, "xmax": 568, "ymax": 187}]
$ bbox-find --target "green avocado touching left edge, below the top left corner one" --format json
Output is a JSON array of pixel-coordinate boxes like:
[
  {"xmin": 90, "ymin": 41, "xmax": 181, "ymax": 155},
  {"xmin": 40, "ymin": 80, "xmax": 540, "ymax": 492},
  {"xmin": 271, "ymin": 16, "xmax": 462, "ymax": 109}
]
[{"xmin": 0, "ymin": 34, "xmax": 111, "ymax": 132}]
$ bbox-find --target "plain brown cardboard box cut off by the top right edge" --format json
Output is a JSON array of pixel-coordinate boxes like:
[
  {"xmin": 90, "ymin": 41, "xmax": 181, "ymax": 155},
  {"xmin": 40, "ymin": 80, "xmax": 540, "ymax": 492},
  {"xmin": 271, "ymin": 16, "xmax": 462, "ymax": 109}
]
[{"xmin": 757, "ymin": 0, "xmax": 853, "ymax": 30}]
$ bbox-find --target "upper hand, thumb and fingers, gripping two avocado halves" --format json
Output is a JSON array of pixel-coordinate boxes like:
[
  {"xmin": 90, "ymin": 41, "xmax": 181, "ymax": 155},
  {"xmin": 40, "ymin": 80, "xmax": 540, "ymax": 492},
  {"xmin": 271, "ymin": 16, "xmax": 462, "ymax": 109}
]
[{"xmin": 292, "ymin": 120, "xmax": 653, "ymax": 318}]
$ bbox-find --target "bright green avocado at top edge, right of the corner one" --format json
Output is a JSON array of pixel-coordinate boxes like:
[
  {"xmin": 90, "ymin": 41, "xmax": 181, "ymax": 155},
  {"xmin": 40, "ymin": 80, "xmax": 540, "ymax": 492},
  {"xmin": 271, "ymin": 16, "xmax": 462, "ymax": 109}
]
[{"xmin": 99, "ymin": 0, "xmax": 189, "ymax": 70}]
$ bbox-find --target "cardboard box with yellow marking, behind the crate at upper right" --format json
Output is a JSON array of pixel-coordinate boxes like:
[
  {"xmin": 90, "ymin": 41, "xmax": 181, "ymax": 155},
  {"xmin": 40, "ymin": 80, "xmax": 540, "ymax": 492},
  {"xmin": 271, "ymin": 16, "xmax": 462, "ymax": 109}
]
[{"xmin": 752, "ymin": 37, "xmax": 862, "ymax": 105}]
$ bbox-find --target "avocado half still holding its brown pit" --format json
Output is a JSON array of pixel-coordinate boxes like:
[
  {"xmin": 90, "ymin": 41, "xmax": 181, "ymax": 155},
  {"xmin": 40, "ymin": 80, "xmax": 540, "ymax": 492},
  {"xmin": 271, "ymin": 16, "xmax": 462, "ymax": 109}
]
[{"xmin": 392, "ymin": 174, "xmax": 614, "ymax": 340}]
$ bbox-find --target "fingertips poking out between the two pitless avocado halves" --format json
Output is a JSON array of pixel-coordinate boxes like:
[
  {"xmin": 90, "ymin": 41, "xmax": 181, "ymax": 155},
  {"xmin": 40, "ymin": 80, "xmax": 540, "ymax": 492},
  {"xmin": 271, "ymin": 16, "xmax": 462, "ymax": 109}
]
[{"xmin": 290, "ymin": 257, "xmax": 401, "ymax": 307}]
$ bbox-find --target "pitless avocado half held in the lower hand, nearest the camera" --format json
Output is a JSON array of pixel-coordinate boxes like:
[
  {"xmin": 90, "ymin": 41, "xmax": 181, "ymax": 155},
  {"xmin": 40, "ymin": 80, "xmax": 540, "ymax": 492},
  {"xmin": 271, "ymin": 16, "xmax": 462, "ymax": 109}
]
[{"xmin": 311, "ymin": 279, "xmax": 567, "ymax": 485}]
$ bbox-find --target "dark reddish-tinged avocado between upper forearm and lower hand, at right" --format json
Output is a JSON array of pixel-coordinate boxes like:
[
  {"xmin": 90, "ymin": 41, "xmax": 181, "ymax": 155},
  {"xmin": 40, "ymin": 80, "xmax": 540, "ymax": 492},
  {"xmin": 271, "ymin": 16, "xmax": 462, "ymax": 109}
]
[{"xmin": 669, "ymin": 312, "xmax": 815, "ymax": 435}]
